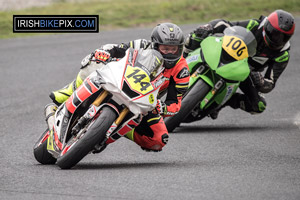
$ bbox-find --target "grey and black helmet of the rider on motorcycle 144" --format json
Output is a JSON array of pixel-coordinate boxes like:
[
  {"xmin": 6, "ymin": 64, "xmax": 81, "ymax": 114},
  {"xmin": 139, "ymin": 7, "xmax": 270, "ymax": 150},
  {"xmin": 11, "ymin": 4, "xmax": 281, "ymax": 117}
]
[{"xmin": 151, "ymin": 23, "xmax": 184, "ymax": 69}]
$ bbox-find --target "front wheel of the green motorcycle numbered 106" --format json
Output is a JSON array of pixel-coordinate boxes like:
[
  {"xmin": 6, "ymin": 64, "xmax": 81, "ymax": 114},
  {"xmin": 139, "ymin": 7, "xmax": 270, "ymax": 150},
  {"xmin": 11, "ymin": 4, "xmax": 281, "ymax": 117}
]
[{"xmin": 165, "ymin": 79, "xmax": 211, "ymax": 132}]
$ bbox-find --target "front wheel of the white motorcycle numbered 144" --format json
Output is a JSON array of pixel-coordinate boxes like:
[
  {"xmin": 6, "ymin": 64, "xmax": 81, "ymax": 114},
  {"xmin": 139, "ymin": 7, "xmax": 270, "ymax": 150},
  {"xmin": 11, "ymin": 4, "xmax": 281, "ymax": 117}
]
[{"xmin": 57, "ymin": 107, "xmax": 117, "ymax": 169}]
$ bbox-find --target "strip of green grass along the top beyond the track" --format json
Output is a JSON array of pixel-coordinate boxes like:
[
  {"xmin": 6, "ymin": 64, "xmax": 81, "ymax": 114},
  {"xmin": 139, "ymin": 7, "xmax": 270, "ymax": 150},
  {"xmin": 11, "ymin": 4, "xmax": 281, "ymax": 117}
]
[{"xmin": 0, "ymin": 0, "xmax": 300, "ymax": 38}]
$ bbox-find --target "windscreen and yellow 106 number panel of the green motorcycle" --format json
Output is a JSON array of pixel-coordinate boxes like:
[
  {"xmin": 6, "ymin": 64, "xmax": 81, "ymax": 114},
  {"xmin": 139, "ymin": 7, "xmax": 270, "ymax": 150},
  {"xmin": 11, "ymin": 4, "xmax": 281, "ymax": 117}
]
[{"xmin": 222, "ymin": 26, "xmax": 257, "ymax": 62}]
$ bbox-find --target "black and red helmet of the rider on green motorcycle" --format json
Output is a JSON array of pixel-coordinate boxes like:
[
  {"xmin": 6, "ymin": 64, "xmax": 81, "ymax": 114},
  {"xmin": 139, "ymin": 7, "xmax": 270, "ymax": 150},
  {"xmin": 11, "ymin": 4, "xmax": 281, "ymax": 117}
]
[{"xmin": 263, "ymin": 10, "xmax": 295, "ymax": 50}]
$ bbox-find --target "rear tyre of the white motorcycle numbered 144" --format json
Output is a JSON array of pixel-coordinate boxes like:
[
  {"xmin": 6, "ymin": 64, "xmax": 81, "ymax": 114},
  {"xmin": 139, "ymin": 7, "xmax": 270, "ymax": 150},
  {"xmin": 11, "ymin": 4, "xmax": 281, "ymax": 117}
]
[{"xmin": 33, "ymin": 129, "xmax": 56, "ymax": 165}]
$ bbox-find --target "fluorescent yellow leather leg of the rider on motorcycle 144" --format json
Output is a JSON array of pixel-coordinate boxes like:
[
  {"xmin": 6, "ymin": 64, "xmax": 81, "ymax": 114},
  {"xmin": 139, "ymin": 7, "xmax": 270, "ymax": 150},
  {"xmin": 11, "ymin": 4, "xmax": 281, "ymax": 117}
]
[{"xmin": 49, "ymin": 74, "xmax": 83, "ymax": 105}]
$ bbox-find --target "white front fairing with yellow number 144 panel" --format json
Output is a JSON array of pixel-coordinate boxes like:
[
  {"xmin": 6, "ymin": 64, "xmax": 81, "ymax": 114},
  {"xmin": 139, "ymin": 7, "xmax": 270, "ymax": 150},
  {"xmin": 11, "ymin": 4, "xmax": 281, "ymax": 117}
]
[{"xmin": 97, "ymin": 49, "xmax": 164, "ymax": 114}]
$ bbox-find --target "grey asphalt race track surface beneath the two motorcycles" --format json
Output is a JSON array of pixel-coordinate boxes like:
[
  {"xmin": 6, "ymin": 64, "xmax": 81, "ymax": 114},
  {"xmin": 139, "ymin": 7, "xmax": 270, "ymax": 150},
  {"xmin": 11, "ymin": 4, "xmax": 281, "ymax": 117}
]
[{"xmin": 0, "ymin": 18, "xmax": 300, "ymax": 200}]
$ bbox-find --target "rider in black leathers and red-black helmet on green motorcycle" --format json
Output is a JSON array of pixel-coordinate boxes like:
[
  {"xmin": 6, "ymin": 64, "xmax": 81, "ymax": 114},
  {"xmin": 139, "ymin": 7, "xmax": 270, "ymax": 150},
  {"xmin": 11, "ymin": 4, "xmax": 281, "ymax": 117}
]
[{"xmin": 184, "ymin": 10, "xmax": 295, "ymax": 119}]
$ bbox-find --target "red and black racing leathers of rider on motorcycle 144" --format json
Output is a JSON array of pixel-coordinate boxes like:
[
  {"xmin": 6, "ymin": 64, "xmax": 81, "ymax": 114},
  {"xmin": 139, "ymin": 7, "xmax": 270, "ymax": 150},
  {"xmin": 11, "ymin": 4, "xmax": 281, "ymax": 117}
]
[{"xmin": 102, "ymin": 39, "xmax": 190, "ymax": 151}]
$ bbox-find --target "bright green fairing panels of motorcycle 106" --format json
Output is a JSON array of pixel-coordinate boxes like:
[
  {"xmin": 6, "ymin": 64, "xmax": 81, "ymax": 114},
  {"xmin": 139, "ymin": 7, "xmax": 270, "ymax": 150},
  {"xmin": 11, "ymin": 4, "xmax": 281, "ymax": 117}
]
[{"xmin": 187, "ymin": 37, "xmax": 250, "ymax": 109}]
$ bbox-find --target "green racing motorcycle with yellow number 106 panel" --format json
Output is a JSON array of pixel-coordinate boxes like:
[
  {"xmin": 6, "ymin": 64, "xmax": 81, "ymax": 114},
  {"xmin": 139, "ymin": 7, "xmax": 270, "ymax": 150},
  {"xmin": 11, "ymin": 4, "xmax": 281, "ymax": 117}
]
[{"xmin": 164, "ymin": 26, "xmax": 257, "ymax": 132}]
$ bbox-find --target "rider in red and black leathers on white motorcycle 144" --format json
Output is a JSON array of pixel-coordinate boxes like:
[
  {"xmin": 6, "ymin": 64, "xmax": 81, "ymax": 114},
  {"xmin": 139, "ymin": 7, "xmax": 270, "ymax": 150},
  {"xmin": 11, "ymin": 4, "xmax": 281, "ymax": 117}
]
[{"xmin": 50, "ymin": 23, "xmax": 190, "ymax": 151}]
